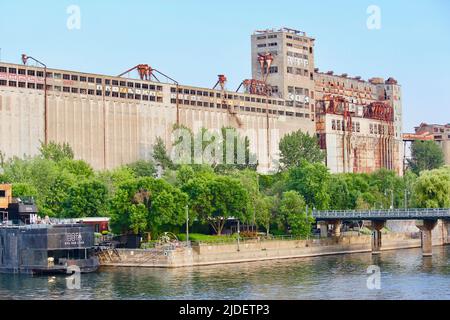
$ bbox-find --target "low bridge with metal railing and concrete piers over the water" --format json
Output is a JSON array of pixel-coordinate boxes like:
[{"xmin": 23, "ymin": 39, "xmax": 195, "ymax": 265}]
[{"xmin": 312, "ymin": 209, "xmax": 450, "ymax": 256}]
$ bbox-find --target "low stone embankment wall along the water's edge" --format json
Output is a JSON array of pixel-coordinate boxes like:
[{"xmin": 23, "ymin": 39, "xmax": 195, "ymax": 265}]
[{"xmin": 102, "ymin": 233, "xmax": 449, "ymax": 268}]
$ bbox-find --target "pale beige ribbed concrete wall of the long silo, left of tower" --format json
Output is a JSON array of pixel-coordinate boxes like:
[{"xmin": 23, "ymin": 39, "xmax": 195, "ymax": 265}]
[{"xmin": 0, "ymin": 64, "xmax": 315, "ymax": 172}]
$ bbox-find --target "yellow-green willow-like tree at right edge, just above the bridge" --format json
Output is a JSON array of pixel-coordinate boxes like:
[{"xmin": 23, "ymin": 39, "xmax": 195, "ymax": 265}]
[{"xmin": 413, "ymin": 167, "xmax": 450, "ymax": 208}]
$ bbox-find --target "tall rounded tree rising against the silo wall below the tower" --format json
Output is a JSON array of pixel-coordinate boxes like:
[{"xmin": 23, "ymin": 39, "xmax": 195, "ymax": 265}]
[{"xmin": 279, "ymin": 130, "xmax": 325, "ymax": 170}]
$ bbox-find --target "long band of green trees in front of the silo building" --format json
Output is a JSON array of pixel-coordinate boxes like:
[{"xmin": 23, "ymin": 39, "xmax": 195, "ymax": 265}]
[{"xmin": 0, "ymin": 130, "xmax": 450, "ymax": 238}]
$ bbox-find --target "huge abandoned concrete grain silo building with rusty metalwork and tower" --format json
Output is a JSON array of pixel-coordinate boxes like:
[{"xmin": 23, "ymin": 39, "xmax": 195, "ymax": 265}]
[{"xmin": 0, "ymin": 28, "xmax": 403, "ymax": 174}]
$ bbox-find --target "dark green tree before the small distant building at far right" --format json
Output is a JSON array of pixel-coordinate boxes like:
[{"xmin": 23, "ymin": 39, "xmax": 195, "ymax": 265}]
[{"xmin": 408, "ymin": 141, "xmax": 445, "ymax": 175}]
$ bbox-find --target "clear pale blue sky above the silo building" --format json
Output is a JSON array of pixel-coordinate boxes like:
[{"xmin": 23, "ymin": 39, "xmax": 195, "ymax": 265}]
[{"xmin": 0, "ymin": 0, "xmax": 450, "ymax": 131}]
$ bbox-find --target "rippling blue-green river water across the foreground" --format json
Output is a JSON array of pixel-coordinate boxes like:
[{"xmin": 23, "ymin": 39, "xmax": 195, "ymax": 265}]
[{"xmin": 0, "ymin": 246, "xmax": 450, "ymax": 300}]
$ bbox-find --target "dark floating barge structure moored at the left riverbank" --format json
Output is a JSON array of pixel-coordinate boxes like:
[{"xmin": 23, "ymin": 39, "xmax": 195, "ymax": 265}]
[{"xmin": 0, "ymin": 185, "xmax": 99, "ymax": 274}]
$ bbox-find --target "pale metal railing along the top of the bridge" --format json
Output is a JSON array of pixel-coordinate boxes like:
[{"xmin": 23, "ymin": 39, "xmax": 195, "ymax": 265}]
[{"xmin": 312, "ymin": 209, "xmax": 450, "ymax": 220}]
